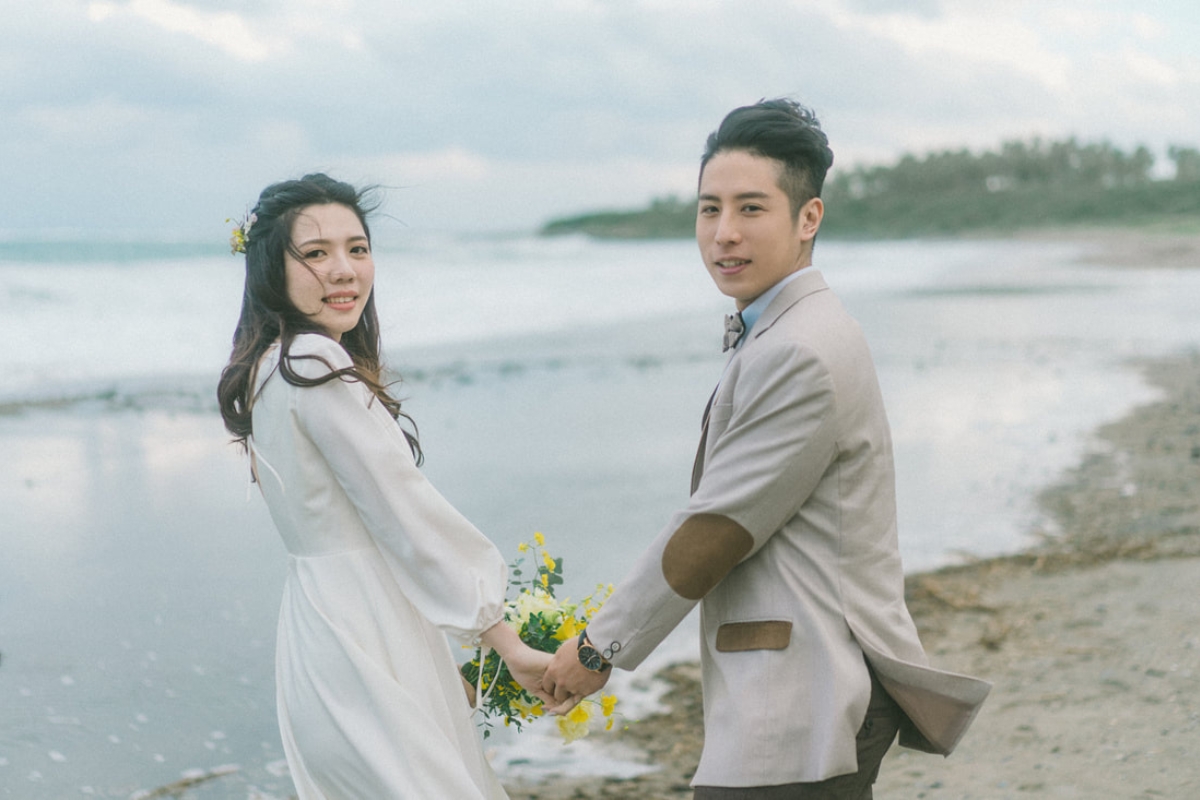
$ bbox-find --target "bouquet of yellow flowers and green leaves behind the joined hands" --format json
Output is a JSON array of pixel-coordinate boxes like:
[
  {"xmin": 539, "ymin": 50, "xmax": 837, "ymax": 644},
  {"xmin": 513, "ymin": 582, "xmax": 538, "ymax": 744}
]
[{"xmin": 462, "ymin": 533, "xmax": 617, "ymax": 742}]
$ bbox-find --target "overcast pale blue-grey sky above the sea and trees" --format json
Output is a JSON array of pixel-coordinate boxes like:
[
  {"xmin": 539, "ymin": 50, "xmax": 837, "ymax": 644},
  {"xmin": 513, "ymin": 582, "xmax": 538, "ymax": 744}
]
[{"xmin": 0, "ymin": 0, "xmax": 1200, "ymax": 237}]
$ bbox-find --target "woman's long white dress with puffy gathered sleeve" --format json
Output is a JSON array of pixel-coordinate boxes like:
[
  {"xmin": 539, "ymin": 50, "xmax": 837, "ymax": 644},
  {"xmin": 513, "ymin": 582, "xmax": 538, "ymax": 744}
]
[{"xmin": 250, "ymin": 333, "xmax": 508, "ymax": 800}]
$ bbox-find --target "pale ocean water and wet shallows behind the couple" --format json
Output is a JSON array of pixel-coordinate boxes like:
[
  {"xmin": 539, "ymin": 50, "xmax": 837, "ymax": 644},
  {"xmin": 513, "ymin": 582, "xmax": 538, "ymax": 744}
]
[{"xmin": 0, "ymin": 237, "xmax": 1200, "ymax": 798}]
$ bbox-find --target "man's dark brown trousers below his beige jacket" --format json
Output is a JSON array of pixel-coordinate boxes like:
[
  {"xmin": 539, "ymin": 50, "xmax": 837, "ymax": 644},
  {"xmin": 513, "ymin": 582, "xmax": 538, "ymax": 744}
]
[{"xmin": 692, "ymin": 668, "xmax": 904, "ymax": 800}]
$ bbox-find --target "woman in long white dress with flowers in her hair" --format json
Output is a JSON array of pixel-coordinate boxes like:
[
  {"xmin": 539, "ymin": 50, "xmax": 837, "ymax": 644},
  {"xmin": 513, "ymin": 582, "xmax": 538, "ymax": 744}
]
[{"xmin": 218, "ymin": 174, "xmax": 550, "ymax": 800}]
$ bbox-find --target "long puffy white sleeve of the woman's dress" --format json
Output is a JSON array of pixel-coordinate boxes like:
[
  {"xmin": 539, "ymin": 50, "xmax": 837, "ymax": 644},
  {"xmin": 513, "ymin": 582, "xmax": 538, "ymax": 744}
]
[{"xmin": 292, "ymin": 336, "xmax": 508, "ymax": 639}]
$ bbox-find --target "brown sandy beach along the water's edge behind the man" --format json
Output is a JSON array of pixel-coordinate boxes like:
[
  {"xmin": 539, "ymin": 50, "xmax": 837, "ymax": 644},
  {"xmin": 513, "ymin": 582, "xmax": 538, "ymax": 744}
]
[{"xmin": 506, "ymin": 350, "xmax": 1200, "ymax": 800}]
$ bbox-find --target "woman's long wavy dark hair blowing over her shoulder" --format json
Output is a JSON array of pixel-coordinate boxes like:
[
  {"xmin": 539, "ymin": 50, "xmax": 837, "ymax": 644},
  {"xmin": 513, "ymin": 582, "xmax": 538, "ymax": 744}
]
[{"xmin": 217, "ymin": 173, "xmax": 422, "ymax": 464}]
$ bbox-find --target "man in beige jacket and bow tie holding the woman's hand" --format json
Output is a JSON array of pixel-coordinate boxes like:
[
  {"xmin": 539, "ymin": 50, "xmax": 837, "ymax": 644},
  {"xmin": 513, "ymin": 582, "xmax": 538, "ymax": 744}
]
[{"xmin": 542, "ymin": 100, "xmax": 990, "ymax": 800}]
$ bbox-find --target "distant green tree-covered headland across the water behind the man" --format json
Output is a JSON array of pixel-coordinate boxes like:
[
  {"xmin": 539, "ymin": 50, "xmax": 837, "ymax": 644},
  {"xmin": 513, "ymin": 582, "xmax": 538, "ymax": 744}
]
[{"xmin": 541, "ymin": 138, "xmax": 1200, "ymax": 239}]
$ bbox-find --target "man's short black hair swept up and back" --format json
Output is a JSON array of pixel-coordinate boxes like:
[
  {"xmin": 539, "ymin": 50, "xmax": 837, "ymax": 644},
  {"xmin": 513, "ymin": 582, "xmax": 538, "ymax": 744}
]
[{"xmin": 700, "ymin": 97, "xmax": 833, "ymax": 217}]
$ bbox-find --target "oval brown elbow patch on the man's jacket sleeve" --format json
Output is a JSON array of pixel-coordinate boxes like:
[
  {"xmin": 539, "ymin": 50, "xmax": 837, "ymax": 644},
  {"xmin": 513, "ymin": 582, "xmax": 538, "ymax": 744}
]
[{"xmin": 662, "ymin": 513, "xmax": 754, "ymax": 600}]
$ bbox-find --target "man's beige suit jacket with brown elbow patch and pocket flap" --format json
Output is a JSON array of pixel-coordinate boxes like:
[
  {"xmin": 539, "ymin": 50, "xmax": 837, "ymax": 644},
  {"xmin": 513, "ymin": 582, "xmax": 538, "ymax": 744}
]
[{"xmin": 588, "ymin": 271, "xmax": 990, "ymax": 787}]
